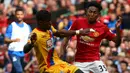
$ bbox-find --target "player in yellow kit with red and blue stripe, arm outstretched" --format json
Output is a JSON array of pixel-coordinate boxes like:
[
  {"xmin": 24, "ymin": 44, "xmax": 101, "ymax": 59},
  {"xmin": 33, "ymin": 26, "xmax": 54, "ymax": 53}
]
[{"xmin": 24, "ymin": 10, "xmax": 90, "ymax": 73}]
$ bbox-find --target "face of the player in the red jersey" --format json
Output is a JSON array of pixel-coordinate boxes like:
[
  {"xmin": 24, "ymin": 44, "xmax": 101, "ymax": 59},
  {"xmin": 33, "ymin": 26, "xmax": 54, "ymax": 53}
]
[{"xmin": 86, "ymin": 6, "xmax": 99, "ymax": 23}]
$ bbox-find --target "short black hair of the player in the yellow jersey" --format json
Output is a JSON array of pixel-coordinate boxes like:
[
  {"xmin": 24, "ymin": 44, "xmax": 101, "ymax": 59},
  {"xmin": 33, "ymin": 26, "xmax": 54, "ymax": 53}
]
[{"xmin": 36, "ymin": 10, "xmax": 51, "ymax": 21}]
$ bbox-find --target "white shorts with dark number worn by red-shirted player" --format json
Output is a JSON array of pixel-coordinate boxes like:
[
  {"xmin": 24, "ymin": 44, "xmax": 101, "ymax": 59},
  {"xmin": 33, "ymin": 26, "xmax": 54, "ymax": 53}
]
[{"xmin": 74, "ymin": 61, "xmax": 108, "ymax": 73}]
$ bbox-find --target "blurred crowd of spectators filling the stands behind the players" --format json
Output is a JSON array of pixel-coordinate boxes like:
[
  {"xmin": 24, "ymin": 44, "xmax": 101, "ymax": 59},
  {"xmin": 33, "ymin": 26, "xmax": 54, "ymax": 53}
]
[{"xmin": 0, "ymin": 0, "xmax": 130, "ymax": 73}]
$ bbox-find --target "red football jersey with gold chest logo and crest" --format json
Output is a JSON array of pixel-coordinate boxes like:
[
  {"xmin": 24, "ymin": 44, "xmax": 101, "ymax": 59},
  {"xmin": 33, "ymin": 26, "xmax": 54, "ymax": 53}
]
[{"xmin": 70, "ymin": 18, "xmax": 115, "ymax": 62}]
